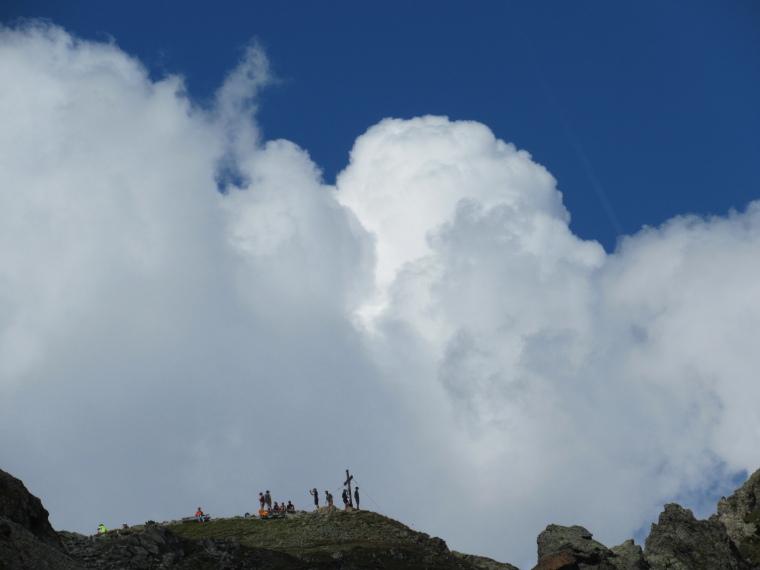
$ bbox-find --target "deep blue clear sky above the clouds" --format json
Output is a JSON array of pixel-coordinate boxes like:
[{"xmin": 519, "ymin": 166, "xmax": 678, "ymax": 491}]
[{"xmin": 5, "ymin": 0, "xmax": 760, "ymax": 251}]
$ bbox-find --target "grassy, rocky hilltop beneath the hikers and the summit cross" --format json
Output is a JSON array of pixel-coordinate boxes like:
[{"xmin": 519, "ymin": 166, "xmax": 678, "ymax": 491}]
[{"xmin": 53, "ymin": 507, "xmax": 514, "ymax": 570}]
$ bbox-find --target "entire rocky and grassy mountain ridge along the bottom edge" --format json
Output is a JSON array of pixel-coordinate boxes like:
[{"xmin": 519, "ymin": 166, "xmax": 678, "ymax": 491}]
[{"xmin": 0, "ymin": 470, "xmax": 760, "ymax": 570}]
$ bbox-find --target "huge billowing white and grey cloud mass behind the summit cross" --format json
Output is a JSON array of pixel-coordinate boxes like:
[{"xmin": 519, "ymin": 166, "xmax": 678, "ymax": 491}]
[{"xmin": 0, "ymin": 24, "xmax": 760, "ymax": 565}]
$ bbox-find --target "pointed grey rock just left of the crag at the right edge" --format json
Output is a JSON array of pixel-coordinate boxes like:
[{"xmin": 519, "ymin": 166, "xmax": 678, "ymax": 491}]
[{"xmin": 644, "ymin": 503, "xmax": 750, "ymax": 570}]
